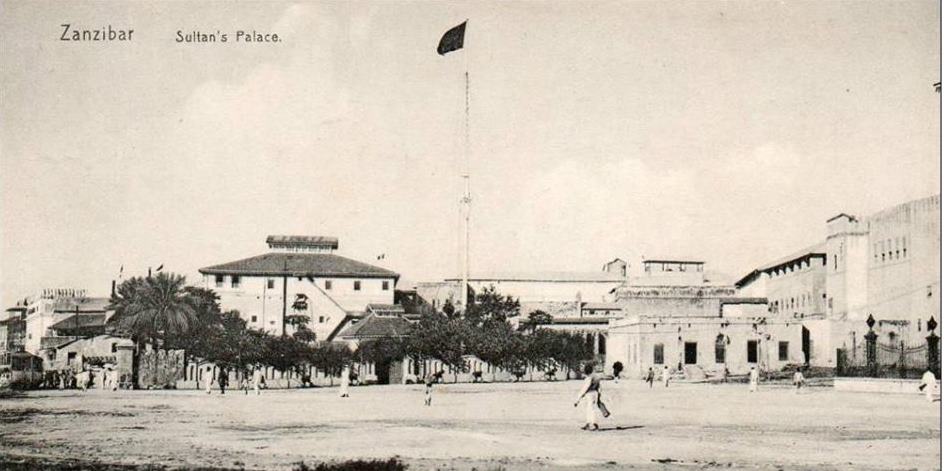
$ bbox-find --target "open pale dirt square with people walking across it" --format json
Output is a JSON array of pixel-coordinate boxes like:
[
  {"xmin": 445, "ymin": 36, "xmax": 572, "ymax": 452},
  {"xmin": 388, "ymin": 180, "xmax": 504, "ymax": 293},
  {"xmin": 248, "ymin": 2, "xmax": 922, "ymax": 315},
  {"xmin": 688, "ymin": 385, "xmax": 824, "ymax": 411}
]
[{"xmin": 0, "ymin": 380, "xmax": 941, "ymax": 470}]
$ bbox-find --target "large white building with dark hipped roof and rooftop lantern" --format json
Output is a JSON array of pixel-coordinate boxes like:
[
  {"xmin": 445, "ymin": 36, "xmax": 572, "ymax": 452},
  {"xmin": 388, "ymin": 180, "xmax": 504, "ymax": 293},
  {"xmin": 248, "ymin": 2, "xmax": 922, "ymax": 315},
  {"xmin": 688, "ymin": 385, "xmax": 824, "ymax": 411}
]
[{"xmin": 200, "ymin": 236, "xmax": 400, "ymax": 340}]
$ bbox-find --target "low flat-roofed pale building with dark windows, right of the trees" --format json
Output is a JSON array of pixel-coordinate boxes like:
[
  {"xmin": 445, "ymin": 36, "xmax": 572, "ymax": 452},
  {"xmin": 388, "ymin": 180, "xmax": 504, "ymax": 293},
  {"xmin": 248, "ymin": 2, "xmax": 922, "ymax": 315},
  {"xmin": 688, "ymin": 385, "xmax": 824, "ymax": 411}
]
[{"xmin": 605, "ymin": 258, "xmax": 803, "ymax": 378}]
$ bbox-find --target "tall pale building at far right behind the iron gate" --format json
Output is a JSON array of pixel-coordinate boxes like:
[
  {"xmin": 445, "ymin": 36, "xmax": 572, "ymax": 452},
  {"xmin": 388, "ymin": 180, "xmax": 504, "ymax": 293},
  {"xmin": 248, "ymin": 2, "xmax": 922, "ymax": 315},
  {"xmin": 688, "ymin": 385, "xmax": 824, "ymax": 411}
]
[{"xmin": 736, "ymin": 195, "xmax": 941, "ymax": 367}]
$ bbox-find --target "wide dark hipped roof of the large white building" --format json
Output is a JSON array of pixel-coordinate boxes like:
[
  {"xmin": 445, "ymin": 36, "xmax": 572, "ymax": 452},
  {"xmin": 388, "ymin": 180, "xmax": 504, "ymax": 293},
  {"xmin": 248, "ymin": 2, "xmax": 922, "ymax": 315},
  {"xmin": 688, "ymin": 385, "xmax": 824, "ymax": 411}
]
[{"xmin": 200, "ymin": 252, "xmax": 400, "ymax": 278}]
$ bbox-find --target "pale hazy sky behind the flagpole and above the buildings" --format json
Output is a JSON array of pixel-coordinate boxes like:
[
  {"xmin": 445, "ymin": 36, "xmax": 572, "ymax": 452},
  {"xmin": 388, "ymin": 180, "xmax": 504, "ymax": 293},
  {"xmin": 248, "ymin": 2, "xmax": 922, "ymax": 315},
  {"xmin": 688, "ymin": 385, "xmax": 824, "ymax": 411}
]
[{"xmin": 0, "ymin": 1, "xmax": 941, "ymax": 306}]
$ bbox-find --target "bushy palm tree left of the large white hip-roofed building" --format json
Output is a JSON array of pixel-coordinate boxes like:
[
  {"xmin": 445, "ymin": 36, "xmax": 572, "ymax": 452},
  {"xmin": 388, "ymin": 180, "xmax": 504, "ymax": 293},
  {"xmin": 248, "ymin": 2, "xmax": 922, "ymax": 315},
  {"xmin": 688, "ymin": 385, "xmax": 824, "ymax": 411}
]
[{"xmin": 109, "ymin": 273, "xmax": 203, "ymax": 346}]
